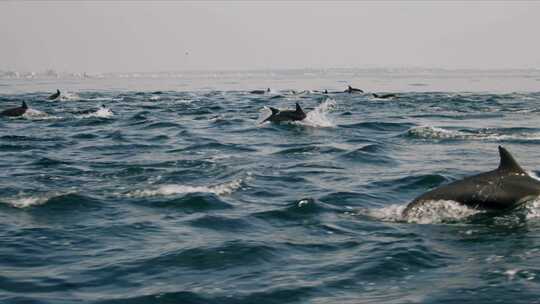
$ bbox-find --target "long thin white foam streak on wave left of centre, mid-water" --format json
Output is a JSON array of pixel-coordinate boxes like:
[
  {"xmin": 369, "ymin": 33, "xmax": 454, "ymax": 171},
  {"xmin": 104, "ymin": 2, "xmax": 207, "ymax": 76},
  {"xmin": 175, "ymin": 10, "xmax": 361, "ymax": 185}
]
[{"xmin": 127, "ymin": 179, "xmax": 243, "ymax": 197}]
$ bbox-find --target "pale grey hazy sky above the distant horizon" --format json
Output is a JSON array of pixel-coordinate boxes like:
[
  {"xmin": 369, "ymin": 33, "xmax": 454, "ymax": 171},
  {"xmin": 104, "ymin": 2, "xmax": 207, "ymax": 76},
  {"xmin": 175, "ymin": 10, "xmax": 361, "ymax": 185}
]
[{"xmin": 0, "ymin": 1, "xmax": 540, "ymax": 72}]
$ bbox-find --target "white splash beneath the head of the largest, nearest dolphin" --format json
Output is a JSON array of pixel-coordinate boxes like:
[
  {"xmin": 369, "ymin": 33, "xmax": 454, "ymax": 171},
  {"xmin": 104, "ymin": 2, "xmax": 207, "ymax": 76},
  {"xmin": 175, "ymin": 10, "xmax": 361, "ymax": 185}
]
[{"xmin": 361, "ymin": 200, "xmax": 482, "ymax": 224}]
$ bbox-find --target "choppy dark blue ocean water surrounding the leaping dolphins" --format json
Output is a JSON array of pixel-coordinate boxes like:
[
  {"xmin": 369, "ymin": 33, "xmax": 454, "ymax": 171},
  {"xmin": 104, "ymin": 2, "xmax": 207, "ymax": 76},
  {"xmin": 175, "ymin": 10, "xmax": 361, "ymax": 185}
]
[{"xmin": 0, "ymin": 70, "xmax": 540, "ymax": 304}]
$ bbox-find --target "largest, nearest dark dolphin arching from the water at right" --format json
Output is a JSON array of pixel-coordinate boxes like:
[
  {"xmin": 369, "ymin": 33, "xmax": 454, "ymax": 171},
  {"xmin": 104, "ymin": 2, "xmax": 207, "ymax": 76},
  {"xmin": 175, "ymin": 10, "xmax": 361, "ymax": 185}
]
[{"xmin": 403, "ymin": 146, "xmax": 540, "ymax": 216}]
